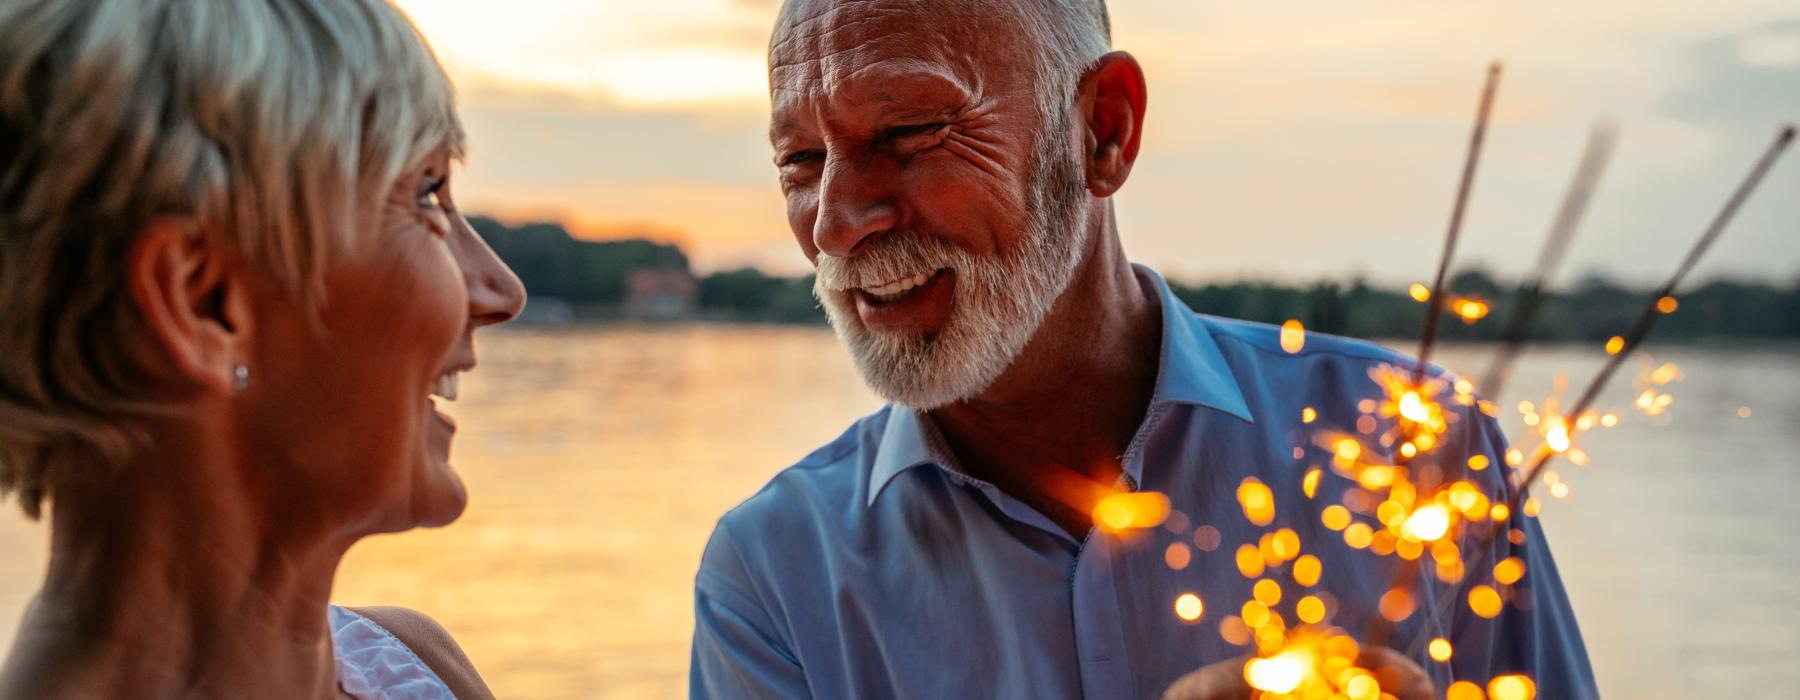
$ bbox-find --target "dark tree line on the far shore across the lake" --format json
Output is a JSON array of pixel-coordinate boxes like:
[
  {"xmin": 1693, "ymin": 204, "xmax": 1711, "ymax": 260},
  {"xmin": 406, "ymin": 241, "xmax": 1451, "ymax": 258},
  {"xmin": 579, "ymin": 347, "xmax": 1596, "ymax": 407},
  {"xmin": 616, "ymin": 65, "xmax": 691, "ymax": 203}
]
[{"xmin": 470, "ymin": 216, "xmax": 1800, "ymax": 342}]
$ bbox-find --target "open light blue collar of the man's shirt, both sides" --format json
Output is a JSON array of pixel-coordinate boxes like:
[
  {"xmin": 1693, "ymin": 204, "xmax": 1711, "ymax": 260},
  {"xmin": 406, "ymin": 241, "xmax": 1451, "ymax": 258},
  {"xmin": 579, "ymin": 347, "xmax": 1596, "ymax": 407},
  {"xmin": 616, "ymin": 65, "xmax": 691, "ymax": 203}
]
[{"xmin": 868, "ymin": 265, "xmax": 1255, "ymax": 506}]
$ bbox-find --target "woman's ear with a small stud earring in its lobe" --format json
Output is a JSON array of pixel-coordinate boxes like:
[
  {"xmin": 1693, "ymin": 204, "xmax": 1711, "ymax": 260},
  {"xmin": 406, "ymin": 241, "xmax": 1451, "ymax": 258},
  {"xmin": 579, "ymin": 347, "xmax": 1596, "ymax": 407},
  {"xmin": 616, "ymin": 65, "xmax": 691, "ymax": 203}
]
[{"xmin": 126, "ymin": 218, "xmax": 250, "ymax": 394}]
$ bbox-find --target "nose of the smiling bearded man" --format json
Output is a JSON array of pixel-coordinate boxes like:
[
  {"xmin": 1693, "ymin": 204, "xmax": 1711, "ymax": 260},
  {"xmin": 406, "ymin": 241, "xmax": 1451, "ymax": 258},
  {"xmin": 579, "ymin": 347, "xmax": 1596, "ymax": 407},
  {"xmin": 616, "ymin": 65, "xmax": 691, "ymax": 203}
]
[{"xmin": 812, "ymin": 157, "xmax": 900, "ymax": 257}]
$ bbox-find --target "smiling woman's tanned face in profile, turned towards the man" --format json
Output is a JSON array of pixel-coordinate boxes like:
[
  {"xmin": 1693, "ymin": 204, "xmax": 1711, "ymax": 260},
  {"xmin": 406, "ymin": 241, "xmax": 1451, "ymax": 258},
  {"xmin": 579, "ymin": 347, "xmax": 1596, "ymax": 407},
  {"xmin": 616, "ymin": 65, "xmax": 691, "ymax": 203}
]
[{"xmin": 243, "ymin": 153, "xmax": 526, "ymax": 534}]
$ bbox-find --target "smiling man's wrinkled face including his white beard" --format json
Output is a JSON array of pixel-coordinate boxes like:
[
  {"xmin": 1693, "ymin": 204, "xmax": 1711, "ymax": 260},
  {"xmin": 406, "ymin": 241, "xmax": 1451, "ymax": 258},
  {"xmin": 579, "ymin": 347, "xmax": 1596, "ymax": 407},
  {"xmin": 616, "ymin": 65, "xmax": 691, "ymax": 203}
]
[{"xmin": 769, "ymin": 0, "xmax": 1087, "ymax": 408}]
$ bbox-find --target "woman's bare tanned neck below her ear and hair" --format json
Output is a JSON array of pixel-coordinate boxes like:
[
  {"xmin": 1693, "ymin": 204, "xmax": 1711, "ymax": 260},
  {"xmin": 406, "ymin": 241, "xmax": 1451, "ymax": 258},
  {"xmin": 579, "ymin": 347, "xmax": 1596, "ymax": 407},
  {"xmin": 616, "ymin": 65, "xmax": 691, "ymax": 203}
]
[{"xmin": 0, "ymin": 417, "xmax": 349, "ymax": 698}]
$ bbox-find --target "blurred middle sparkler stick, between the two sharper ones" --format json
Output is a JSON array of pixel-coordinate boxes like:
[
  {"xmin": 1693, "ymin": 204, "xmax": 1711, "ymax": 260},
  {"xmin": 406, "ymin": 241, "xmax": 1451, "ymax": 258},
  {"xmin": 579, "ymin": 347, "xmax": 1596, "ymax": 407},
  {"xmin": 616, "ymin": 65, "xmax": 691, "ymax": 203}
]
[{"xmin": 1476, "ymin": 122, "xmax": 1616, "ymax": 401}]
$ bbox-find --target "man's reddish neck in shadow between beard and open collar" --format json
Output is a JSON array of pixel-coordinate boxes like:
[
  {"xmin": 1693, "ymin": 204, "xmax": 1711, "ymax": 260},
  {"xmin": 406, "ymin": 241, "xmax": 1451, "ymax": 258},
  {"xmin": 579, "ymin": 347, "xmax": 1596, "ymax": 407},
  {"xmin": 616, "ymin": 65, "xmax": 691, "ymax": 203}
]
[{"xmin": 931, "ymin": 211, "xmax": 1163, "ymax": 536}]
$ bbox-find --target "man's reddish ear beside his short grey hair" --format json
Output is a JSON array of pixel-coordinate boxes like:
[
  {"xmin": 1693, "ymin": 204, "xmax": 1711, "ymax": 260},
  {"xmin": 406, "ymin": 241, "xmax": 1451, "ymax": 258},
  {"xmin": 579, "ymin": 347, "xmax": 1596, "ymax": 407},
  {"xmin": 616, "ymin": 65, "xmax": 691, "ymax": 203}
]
[{"xmin": 1078, "ymin": 50, "xmax": 1148, "ymax": 196}]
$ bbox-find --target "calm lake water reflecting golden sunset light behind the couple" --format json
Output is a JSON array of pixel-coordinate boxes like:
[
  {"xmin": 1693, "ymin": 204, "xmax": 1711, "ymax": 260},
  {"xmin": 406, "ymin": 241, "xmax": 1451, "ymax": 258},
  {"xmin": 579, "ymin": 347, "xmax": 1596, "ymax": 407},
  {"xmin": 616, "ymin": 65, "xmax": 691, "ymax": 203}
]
[{"xmin": 0, "ymin": 326, "xmax": 1800, "ymax": 698}]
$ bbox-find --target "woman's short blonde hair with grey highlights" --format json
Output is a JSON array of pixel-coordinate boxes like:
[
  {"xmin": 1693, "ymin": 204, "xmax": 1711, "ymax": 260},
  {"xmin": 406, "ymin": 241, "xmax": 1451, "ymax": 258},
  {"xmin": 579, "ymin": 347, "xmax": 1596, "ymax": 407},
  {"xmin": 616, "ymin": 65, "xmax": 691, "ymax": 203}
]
[{"xmin": 0, "ymin": 0, "xmax": 463, "ymax": 516}]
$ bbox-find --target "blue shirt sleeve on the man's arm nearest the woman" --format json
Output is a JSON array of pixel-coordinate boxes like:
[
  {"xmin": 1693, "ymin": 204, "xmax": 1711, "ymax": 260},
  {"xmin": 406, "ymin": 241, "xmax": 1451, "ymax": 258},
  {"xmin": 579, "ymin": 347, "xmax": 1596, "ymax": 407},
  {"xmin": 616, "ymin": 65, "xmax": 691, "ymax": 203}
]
[{"xmin": 688, "ymin": 522, "xmax": 812, "ymax": 700}]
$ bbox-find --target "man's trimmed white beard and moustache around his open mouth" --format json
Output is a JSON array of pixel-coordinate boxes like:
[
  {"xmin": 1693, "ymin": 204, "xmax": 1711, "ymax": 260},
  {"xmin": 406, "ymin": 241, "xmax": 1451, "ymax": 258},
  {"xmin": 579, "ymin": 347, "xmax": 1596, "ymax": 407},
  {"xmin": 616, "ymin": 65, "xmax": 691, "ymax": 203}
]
[{"xmin": 814, "ymin": 117, "xmax": 1087, "ymax": 410}]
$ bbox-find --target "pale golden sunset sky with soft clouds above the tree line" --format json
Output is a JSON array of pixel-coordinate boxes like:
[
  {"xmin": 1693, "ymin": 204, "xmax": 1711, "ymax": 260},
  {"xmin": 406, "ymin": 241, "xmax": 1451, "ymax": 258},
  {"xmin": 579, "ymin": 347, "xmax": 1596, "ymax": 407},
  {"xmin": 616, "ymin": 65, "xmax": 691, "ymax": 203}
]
[{"xmin": 401, "ymin": 0, "xmax": 1800, "ymax": 283}]
